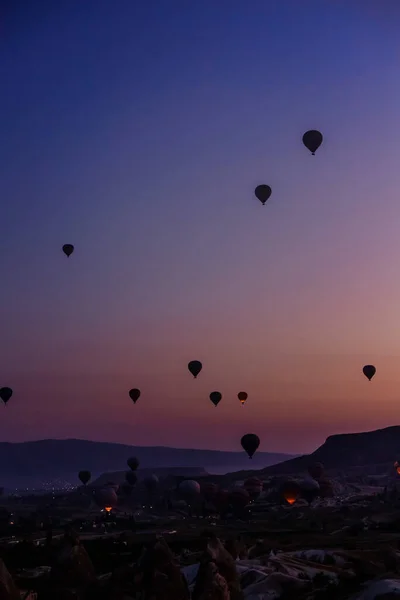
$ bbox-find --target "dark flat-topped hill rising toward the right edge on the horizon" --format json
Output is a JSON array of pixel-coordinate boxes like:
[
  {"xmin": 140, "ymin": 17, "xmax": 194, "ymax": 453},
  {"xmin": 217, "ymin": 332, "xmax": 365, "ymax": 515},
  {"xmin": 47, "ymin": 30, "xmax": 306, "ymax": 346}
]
[{"xmin": 256, "ymin": 425, "xmax": 400, "ymax": 475}]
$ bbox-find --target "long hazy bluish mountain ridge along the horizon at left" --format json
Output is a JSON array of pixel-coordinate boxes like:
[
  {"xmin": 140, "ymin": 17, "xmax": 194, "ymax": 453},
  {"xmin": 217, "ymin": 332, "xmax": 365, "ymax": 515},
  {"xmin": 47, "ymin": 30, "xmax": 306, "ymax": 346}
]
[{"xmin": 0, "ymin": 439, "xmax": 293, "ymax": 480}]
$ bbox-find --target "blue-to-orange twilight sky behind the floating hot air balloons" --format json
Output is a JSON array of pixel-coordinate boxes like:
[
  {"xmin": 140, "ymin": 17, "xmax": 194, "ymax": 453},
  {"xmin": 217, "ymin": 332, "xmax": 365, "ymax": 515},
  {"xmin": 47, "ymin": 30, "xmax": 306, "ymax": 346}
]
[{"xmin": 0, "ymin": 0, "xmax": 400, "ymax": 452}]
